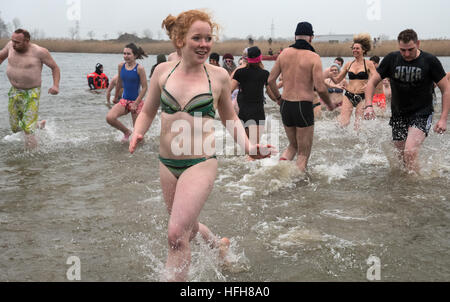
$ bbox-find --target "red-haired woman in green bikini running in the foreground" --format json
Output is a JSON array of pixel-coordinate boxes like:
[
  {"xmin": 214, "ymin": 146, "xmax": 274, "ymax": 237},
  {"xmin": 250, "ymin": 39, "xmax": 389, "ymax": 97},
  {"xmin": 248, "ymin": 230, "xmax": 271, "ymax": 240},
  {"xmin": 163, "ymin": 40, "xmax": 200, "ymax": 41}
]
[{"xmin": 130, "ymin": 10, "xmax": 275, "ymax": 281}]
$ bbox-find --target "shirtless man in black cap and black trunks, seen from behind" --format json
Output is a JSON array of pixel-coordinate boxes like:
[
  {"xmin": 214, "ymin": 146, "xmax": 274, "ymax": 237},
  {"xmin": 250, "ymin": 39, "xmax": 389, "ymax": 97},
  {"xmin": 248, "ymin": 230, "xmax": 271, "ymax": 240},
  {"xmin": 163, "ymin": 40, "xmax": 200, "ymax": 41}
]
[{"xmin": 268, "ymin": 22, "xmax": 335, "ymax": 172}]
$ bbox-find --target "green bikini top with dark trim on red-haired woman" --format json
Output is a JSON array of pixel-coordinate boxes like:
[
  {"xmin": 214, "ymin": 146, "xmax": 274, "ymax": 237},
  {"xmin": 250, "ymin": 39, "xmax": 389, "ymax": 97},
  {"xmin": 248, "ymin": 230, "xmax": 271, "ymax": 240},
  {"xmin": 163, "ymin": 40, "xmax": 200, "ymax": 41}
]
[{"xmin": 161, "ymin": 63, "xmax": 216, "ymax": 118}]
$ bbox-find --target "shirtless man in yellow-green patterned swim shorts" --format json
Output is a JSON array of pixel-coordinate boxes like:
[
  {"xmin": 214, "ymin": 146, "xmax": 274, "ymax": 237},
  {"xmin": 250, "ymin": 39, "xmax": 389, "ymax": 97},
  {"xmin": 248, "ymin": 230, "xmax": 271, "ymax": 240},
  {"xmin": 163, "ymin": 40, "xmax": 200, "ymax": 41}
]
[{"xmin": 0, "ymin": 29, "xmax": 61, "ymax": 149}]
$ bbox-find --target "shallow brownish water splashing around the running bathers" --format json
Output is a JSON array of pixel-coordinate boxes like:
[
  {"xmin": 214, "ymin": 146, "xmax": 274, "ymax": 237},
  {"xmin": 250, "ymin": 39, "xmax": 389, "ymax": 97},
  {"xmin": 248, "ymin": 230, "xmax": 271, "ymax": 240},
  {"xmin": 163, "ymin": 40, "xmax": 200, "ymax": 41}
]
[{"xmin": 0, "ymin": 53, "xmax": 450, "ymax": 281}]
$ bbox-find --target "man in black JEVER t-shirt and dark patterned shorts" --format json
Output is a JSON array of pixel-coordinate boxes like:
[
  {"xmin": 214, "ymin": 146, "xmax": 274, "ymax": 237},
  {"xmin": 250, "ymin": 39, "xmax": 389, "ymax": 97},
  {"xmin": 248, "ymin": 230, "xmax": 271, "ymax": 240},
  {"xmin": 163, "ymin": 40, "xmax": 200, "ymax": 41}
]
[{"xmin": 364, "ymin": 29, "xmax": 450, "ymax": 172}]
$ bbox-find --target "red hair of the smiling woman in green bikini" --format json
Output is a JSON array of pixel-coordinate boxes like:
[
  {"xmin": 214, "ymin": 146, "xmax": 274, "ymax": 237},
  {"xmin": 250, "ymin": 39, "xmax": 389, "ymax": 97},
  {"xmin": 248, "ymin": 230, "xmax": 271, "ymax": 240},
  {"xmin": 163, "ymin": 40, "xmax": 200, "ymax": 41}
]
[{"xmin": 161, "ymin": 10, "xmax": 219, "ymax": 48}]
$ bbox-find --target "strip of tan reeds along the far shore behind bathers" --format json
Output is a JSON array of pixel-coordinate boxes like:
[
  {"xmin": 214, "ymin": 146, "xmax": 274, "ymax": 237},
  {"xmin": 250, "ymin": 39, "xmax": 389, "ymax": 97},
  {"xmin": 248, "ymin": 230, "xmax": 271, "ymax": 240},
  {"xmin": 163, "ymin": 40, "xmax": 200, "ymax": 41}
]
[{"xmin": 0, "ymin": 39, "xmax": 450, "ymax": 57}]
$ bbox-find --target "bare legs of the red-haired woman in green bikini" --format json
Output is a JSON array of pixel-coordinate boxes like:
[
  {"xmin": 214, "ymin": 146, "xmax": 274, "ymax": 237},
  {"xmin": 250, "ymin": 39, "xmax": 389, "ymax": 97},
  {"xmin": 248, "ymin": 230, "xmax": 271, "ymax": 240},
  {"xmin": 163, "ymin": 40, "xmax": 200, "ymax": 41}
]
[{"xmin": 160, "ymin": 159, "xmax": 229, "ymax": 281}]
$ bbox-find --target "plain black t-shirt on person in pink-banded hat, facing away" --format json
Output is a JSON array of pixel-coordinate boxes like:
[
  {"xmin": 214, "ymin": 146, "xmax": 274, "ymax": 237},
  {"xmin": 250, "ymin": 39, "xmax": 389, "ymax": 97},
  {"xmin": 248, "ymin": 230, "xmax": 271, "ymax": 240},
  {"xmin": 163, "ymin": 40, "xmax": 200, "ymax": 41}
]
[{"xmin": 233, "ymin": 67, "xmax": 269, "ymax": 103}]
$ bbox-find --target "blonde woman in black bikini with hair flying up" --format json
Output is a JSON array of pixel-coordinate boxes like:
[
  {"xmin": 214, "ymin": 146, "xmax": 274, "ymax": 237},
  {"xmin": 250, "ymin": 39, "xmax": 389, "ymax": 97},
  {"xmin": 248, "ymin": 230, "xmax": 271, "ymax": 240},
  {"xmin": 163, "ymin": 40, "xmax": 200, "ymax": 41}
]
[{"xmin": 331, "ymin": 34, "xmax": 376, "ymax": 130}]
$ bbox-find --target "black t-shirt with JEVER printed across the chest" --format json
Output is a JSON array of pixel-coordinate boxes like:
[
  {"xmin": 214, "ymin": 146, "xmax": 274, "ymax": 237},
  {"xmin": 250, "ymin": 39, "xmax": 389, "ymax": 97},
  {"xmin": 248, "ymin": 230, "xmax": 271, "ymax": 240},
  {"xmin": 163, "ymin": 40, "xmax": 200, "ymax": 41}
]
[{"xmin": 377, "ymin": 51, "xmax": 446, "ymax": 116}]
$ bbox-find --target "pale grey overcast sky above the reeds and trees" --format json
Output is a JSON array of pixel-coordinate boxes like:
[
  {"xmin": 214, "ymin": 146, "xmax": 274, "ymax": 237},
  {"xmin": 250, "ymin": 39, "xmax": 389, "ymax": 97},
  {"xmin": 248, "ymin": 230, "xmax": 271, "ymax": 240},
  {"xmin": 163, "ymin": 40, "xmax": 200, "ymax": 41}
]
[{"xmin": 0, "ymin": 0, "xmax": 450, "ymax": 39}]
